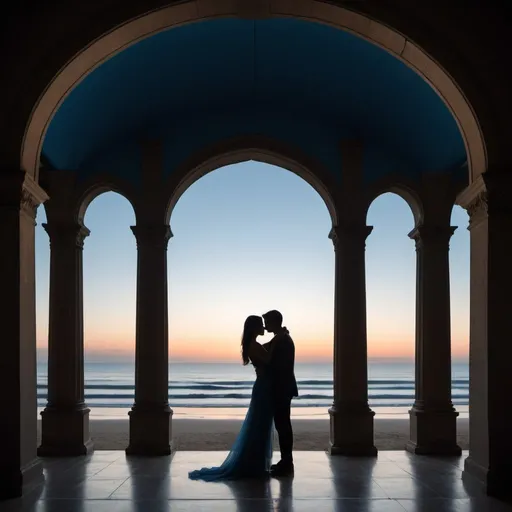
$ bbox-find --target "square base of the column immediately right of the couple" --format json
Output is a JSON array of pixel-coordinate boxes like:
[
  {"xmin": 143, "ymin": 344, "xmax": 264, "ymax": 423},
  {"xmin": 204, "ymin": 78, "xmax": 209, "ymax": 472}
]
[{"xmin": 328, "ymin": 405, "xmax": 377, "ymax": 457}]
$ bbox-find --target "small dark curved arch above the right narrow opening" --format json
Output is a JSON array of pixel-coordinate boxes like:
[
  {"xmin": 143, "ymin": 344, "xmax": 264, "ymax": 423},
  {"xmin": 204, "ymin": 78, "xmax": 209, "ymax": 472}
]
[{"xmin": 365, "ymin": 175, "xmax": 425, "ymax": 226}]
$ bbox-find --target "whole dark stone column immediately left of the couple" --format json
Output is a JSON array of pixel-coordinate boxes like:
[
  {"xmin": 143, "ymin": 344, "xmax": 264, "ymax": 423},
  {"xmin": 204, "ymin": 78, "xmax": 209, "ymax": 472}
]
[{"xmin": 126, "ymin": 225, "xmax": 172, "ymax": 455}]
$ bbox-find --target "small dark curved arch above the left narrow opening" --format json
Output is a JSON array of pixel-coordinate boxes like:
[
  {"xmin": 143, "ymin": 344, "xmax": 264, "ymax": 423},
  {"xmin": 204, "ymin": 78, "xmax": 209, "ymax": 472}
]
[{"xmin": 75, "ymin": 175, "xmax": 137, "ymax": 224}]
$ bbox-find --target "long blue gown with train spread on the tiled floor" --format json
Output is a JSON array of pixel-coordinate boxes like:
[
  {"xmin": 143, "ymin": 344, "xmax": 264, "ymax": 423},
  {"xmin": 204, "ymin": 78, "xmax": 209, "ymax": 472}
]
[{"xmin": 189, "ymin": 368, "xmax": 273, "ymax": 481}]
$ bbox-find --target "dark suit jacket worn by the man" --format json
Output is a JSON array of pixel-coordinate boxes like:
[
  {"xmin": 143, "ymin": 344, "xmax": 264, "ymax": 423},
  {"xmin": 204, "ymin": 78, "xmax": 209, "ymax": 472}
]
[{"xmin": 267, "ymin": 330, "xmax": 299, "ymax": 399}]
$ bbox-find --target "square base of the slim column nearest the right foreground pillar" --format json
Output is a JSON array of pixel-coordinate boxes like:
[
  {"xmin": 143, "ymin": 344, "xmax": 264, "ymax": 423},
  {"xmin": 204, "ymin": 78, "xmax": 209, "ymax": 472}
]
[{"xmin": 405, "ymin": 406, "xmax": 462, "ymax": 456}]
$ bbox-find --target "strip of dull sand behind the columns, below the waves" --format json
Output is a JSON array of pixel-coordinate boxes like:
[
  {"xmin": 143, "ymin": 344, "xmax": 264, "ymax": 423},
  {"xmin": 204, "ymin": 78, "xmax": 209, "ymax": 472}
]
[{"xmin": 38, "ymin": 418, "xmax": 469, "ymax": 451}]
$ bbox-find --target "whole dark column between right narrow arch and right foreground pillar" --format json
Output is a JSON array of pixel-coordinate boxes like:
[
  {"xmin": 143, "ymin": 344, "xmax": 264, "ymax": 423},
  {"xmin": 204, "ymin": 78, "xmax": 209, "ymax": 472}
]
[{"xmin": 406, "ymin": 225, "xmax": 461, "ymax": 455}]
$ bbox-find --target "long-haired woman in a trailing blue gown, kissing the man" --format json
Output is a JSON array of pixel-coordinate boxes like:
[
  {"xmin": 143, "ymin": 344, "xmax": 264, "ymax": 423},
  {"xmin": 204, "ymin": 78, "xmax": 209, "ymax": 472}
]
[{"xmin": 189, "ymin": 316, "xmax": 273, "ymax": 481}]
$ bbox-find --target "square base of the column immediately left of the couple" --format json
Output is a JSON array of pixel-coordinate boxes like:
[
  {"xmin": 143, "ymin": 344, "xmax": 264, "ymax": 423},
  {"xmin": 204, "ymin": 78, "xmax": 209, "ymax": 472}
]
[{"xmin": 126, "ymin": 406, "xmax": 172, "ymax": 457}]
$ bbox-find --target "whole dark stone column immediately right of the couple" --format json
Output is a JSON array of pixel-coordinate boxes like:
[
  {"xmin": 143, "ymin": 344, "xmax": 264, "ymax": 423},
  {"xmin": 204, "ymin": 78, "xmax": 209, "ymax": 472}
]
[{"xmin": 329, "ymin": 224, "xmax": 377, "ymax": 455}]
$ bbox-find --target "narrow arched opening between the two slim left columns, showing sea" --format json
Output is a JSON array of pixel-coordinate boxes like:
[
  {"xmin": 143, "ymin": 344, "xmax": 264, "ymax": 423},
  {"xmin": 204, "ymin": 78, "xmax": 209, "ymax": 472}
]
[{"xmin": 83, "ymin": 190, "xmax": 137, "ymax": 432}]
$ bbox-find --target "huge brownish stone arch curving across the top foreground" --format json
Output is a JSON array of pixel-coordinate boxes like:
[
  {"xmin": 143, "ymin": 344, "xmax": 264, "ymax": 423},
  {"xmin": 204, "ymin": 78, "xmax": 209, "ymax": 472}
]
[{"xmin": 21, "ymin": 0, "xmax": 487, "ymax": 182}]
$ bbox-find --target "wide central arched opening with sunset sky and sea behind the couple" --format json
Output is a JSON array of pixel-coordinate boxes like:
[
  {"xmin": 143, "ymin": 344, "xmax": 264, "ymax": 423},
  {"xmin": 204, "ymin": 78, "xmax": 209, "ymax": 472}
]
[{"xmin": 168, "ymin": 161, "xmax": 334, "ymax": 442}]
